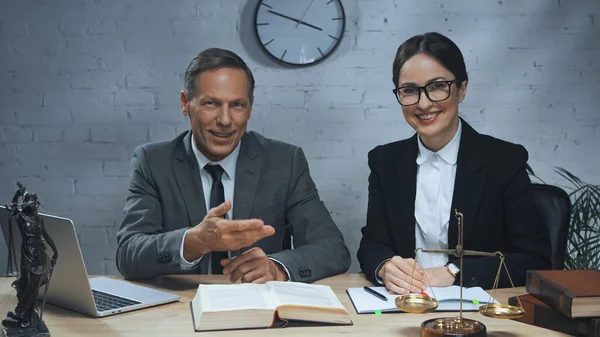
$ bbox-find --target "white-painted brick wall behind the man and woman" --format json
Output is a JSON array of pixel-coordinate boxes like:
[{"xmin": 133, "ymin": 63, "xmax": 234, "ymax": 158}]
[{"xmin": 0, "ymin": 0, "xmax": 600, "ymax": 273}]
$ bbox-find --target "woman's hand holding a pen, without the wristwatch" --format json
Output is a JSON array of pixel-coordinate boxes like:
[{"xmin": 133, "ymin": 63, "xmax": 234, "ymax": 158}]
[{"xmin": 377, "ymin": 256, "xmax": 427, "ymax": 295}]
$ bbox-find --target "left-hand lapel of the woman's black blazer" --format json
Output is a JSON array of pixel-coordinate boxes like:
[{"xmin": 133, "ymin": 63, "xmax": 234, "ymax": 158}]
[{"xmin": 386, "ymin": 134, "xmax": 418, "ymax": 257}]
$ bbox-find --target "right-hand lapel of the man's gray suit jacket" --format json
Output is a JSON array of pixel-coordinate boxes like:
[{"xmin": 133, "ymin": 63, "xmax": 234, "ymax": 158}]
[{"xmin": 233, "ymin": 133, "xmax": 264, "ymax": 219}]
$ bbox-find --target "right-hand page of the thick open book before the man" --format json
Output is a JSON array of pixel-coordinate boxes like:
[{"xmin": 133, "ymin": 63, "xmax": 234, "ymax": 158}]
[{"xmin": 267, "ymin": 281, "xmax": 346, "ymax": 310}]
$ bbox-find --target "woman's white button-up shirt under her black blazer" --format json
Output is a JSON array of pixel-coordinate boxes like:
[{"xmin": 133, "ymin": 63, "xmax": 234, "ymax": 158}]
[{"xmin": 415, "ymin": 119, "xmax": 462, "ymax": 268}]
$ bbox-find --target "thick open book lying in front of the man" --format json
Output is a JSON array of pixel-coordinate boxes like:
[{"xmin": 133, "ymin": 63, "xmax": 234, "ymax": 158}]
[{"xmin": 191, "ymin": 281, "xmax": 352, "ymax": 331}]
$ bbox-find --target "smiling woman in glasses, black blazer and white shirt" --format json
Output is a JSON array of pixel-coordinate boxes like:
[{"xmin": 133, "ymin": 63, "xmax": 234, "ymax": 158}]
[{"xmin": 358, "ymin": 33, "xmax": 551, "ymax": 294}]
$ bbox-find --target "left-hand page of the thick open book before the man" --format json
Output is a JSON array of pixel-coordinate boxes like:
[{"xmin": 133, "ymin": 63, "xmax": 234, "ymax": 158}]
[{"xmin": 198, "ymin": 284, "xmax": 275, "ymax": 312}]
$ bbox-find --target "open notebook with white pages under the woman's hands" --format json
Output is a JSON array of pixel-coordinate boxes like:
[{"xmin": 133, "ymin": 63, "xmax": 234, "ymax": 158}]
[{"xmin": 347, "ymin": 286, "xmax": 498, "ymax": 314}]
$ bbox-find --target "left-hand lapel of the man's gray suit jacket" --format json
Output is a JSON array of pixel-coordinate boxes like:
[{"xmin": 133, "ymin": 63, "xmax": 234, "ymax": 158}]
[{"xmin": 175, "ymin": 131, "xmax": 207, "ymax": 226}]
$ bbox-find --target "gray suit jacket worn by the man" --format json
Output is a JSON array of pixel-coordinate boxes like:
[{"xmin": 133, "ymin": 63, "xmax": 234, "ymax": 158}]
[{"xmin": 117, "ymin": 131, "xmax": 350, "ymax": 282}]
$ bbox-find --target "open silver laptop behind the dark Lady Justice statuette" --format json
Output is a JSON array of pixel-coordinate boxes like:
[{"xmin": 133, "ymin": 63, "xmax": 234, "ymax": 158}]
[{"xmin": 0, "ymin": 206, "xmax": 181, "ymax": 317}]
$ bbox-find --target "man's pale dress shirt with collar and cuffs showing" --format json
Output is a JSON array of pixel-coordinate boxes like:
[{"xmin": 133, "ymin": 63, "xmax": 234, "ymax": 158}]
[{"xmin": 179, "ymin": 134, "xmax": 291, "ymax": 280}]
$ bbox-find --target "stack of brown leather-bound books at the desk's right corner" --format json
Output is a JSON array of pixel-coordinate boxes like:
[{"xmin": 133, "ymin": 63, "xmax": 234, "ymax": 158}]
[{"xmin": 508, "ymin": 270, "xmax": 600, "ymax": 337}]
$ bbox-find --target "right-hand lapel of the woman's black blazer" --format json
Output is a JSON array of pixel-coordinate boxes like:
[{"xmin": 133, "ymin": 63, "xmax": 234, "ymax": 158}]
[{"xmin": 448, "ymin": 119, "xmax": 487, "ymax": 249}]
